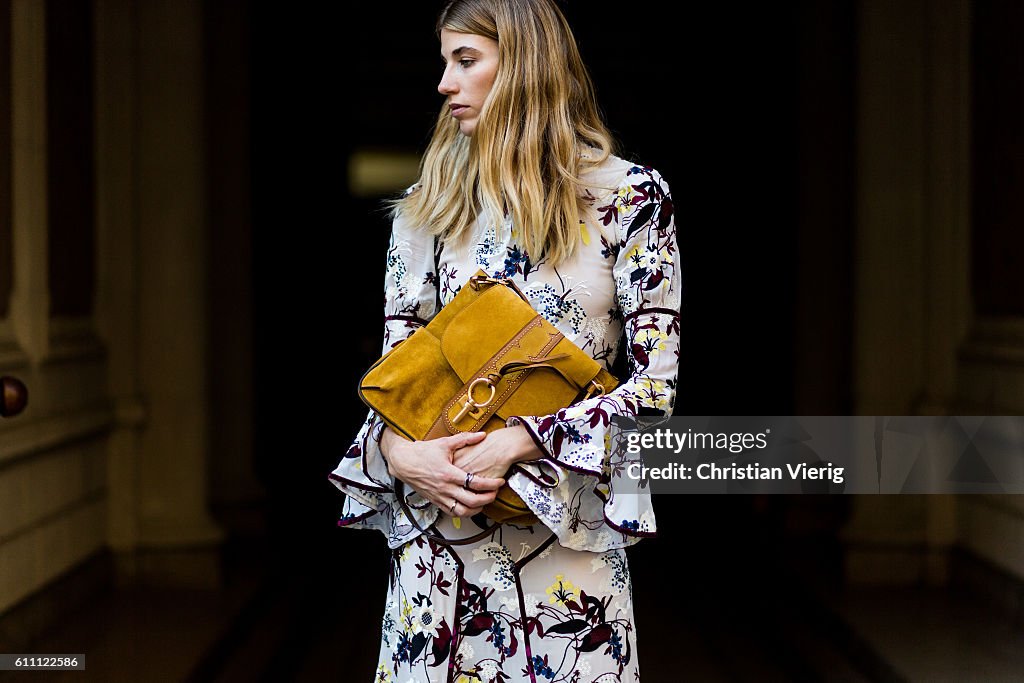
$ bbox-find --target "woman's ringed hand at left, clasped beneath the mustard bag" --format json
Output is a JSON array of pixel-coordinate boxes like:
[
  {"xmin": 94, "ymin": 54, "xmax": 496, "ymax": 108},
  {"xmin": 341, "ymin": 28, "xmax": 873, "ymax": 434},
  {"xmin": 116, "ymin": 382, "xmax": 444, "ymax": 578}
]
[{"xmin": 381, "ymin": 428, "xmax": 505, "ymax": 517}]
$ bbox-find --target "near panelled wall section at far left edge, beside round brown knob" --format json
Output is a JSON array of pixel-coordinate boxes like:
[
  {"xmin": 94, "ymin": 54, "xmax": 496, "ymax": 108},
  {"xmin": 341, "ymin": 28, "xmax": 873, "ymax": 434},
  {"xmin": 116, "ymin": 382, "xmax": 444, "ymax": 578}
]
[{"xmin": 0, "ymin": 0, "xmax": 114, "ymax": 611}]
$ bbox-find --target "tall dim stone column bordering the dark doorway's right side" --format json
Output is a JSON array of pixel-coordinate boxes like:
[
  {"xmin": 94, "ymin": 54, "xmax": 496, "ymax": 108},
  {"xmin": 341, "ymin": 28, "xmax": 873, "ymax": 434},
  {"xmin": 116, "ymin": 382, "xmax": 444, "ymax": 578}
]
[{"xmin": 844, "ymin": 0, "xmax": 971, "ymax": 584}]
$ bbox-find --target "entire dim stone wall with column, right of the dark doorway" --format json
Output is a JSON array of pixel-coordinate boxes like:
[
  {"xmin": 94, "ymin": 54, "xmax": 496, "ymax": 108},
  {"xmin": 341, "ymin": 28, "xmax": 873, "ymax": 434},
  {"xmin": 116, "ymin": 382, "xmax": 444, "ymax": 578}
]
[{"xmin": 843, "ymin": 0, "xmax": 1024, "ymax": 592}]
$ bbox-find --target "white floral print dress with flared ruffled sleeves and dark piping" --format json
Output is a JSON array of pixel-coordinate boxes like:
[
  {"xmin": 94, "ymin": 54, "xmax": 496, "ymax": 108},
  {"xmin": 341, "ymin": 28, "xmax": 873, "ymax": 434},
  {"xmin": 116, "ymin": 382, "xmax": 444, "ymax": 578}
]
[{"xmin": 329, "ymin": 156, "xmax": 680, "ymax": 683}]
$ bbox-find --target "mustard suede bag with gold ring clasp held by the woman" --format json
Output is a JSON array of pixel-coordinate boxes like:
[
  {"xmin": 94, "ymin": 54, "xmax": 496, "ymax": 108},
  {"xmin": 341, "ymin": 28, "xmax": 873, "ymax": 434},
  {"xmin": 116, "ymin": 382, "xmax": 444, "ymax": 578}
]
[{"xmin": 359, "ymin": 270, "xmax": 618, "ymax": 525}]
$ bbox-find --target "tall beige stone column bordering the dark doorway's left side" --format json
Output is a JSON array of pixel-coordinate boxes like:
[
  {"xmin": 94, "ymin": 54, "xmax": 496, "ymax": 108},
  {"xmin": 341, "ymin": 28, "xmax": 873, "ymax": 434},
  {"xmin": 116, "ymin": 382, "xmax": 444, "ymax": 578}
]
[{"xmin": 134, "ymin": 0, "xmax": 222, "ymax": 565}]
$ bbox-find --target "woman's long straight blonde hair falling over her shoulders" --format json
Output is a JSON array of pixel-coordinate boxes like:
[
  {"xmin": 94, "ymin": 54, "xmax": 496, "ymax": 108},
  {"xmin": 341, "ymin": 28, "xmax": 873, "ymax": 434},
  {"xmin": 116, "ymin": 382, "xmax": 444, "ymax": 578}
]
[{"xmin": 389, "ymin": 0, "xmax": 614, "ymax": 266}]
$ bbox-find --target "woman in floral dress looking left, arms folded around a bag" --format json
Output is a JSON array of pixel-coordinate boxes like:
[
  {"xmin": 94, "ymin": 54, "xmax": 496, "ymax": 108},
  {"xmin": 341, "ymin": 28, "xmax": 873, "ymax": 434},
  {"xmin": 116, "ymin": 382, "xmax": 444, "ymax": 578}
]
[{"xmin": 331, "ymin": 0, "xmax": 680, "ymax": 683}]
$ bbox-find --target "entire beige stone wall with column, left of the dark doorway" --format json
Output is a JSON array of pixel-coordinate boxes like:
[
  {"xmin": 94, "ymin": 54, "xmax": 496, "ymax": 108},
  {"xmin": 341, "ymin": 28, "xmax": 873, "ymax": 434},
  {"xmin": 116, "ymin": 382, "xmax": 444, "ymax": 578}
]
[{"xmin": 0, "ymin": 0, "xmax": 258, "ymax": 629}]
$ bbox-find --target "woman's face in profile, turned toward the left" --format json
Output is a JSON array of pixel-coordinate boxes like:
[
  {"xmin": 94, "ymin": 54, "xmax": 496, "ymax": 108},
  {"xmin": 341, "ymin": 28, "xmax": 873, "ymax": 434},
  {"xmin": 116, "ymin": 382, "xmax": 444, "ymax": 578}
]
[{"xmin": 437, "ymin": 29, "xmax": 498, "ymax": 135}]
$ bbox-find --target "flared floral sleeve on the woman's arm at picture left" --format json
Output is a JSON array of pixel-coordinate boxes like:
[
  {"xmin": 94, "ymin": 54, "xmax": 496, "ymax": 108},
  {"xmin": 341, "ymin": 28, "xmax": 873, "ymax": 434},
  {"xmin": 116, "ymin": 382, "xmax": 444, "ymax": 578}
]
[{"xmin": 328, "ymin": 201, "xmax": 437, "ymax": 548}]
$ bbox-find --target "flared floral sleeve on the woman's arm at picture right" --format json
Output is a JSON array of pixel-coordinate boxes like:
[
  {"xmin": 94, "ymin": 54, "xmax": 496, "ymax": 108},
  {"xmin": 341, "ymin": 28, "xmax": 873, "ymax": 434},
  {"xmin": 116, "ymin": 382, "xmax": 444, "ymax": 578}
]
[{"xmin": 507, "ymin": 166, "xmax": 681, "ymax": 552}]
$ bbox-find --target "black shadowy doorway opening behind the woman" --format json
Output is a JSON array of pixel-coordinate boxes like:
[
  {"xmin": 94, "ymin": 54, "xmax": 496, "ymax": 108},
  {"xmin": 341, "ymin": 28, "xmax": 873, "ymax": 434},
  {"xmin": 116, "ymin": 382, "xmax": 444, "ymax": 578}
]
[{"xmin": 250, "ymin": 2, "xmax": 853, "ymax": 680}]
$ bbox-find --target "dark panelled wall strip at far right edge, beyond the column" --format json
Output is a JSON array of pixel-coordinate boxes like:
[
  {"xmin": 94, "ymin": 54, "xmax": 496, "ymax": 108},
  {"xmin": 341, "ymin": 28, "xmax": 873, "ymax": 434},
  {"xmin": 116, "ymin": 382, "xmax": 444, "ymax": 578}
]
[{"xmin": 942, "ymin": 3, "xmax": 1024, "ymax": 585}]
